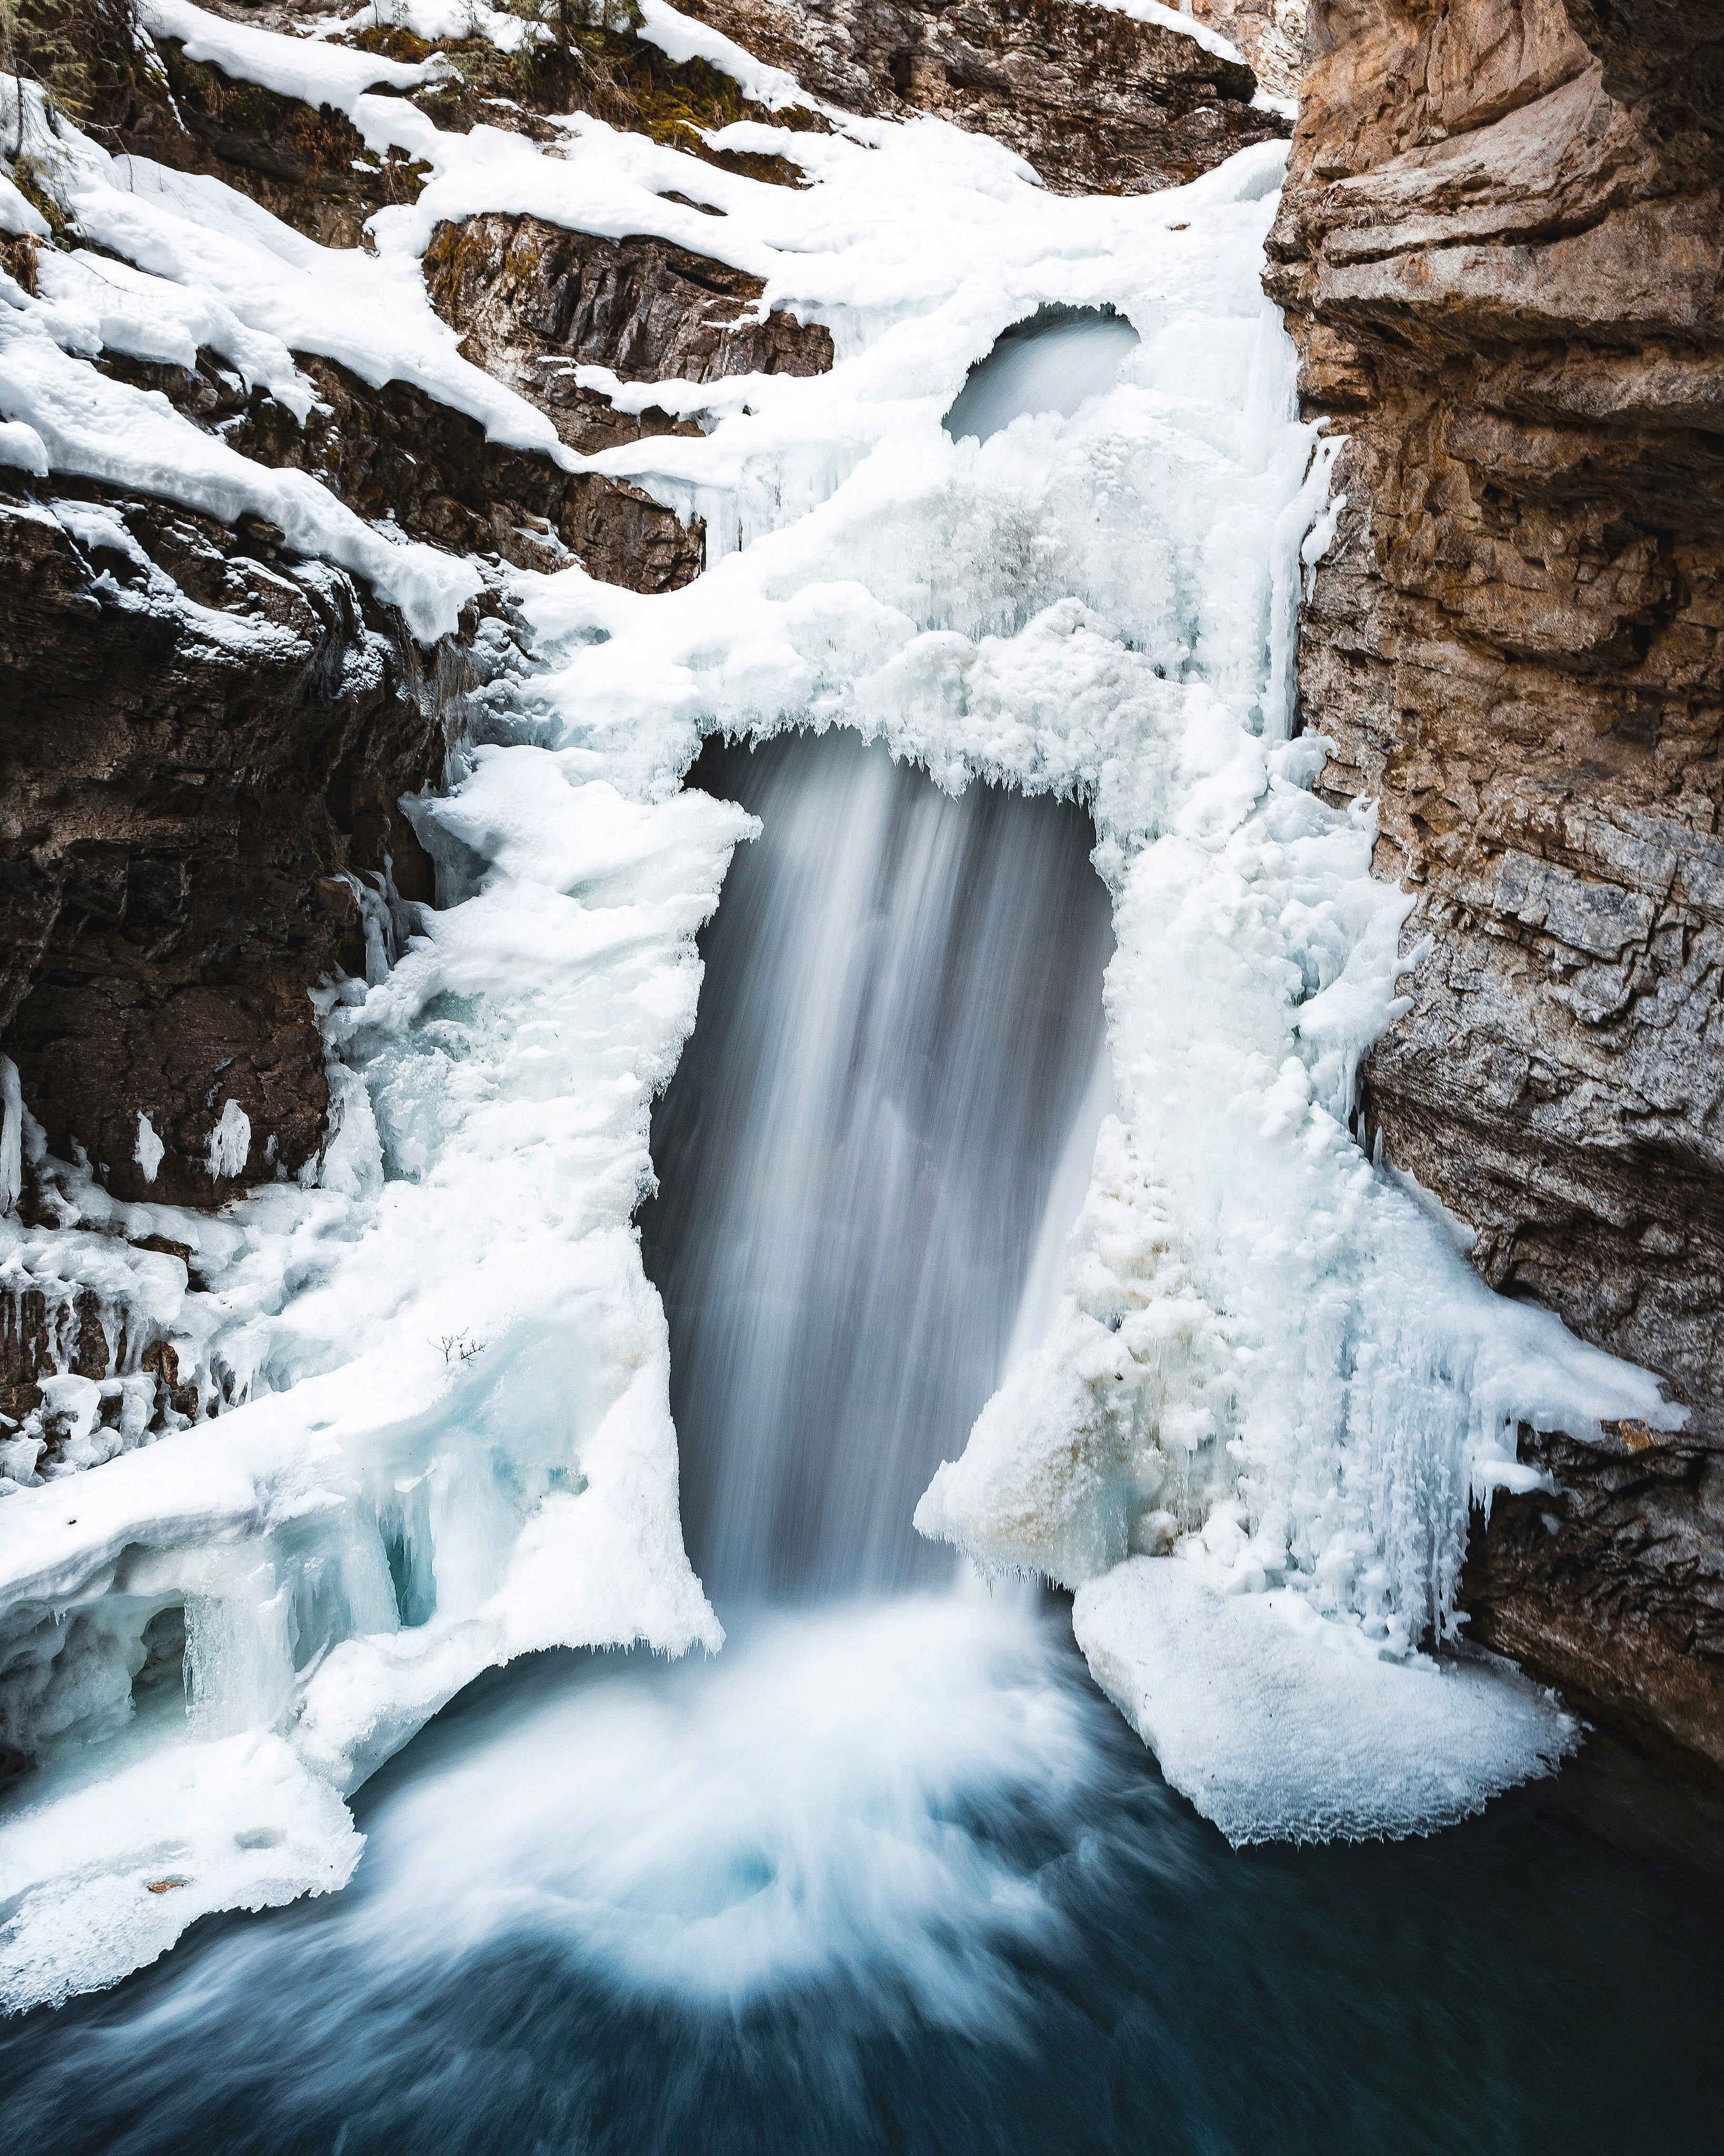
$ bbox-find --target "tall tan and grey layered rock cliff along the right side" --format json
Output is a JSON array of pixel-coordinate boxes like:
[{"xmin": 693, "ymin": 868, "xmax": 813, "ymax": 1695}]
[{"xmin": 1267, "ymin": 0, "xmax": 1724, "ymax": 1764}]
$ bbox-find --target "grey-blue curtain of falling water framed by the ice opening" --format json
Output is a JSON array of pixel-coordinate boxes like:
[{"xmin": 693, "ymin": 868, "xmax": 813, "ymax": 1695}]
[{"xmin": 642, "ymin": 735, "xmax": 1112, "ymax": 1602}]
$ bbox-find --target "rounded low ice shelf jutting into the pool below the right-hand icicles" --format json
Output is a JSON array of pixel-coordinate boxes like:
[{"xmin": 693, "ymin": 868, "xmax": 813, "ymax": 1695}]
[{"xmin": 1071, "ymin": 1556, "xmax": 1575, "ymax": 1848}]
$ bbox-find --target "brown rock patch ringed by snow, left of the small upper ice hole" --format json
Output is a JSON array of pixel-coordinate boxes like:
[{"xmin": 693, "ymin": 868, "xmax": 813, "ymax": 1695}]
[{"xmin": 425, "ymin": 216, "xmax": 832, "ymax": 453}]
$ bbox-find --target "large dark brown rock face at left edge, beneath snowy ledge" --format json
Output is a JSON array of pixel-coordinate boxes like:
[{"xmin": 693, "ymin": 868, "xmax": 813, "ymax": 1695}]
[{"xmin": 0, "ymin": 474, "xmax": 463, "ymax": 1205}]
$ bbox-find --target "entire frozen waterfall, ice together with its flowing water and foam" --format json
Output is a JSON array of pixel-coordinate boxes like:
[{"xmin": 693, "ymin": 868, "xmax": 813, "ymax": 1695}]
[{"xmin": 0, "ymin": 97, "xmax": 1670, "ymax": 2035}]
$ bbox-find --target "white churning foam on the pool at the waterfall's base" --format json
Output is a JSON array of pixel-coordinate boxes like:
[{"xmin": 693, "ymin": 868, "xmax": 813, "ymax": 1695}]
[{"xmin": 327, "ymin": 1595, "xmax": 1092, "ymax": 2027}]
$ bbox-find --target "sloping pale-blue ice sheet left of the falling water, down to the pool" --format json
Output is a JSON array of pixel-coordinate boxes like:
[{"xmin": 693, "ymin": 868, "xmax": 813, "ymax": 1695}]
[{"xmin": 0, "ymin": 746, "xmax": 750, "ymax": 2007}]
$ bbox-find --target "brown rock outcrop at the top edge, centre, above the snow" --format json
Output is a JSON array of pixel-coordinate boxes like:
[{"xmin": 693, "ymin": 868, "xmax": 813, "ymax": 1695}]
[{"xmin": 685, "ymin": 0, "xmax": 1287, "ymax": 194}]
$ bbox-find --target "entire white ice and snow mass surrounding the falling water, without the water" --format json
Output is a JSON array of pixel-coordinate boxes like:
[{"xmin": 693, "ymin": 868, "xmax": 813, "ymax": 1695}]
[{"xmin": 0, "ymin": 0, "xmax": 1670, "ymax": 2005}]
